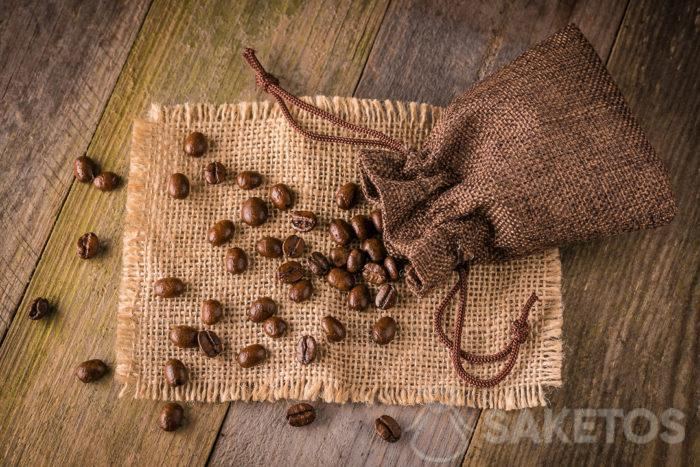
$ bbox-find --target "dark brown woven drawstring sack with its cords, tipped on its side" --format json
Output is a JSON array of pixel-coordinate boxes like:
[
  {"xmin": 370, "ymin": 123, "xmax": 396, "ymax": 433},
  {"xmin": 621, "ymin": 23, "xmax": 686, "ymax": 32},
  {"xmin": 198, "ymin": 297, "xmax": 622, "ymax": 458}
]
[{"xmin": 243, "ymin": 25, "xmax": 676, "ymax": 387}]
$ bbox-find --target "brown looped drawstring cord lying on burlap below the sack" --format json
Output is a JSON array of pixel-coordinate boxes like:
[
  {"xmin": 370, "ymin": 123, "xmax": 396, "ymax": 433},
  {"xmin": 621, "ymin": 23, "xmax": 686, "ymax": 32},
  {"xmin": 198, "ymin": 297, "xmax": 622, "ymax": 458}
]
[{"xmin": 433, "ymin": 266, "xmax": 539, "ymax": 388}]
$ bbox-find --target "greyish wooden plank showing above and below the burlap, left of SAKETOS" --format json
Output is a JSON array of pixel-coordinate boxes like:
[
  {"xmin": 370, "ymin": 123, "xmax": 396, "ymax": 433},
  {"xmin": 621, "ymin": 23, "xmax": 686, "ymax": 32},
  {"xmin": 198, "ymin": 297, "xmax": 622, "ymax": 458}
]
[{"xmin": 211, "ymin": 1, "xmax": 624, "ymax": 465}]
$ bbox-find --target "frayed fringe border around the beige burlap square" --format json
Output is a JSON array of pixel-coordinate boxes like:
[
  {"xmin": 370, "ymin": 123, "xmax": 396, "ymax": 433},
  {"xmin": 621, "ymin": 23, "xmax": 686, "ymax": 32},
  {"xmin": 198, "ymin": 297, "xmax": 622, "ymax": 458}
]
[{"xmin": 116, "ymin": 96, "xmax": 563, "ymax": 410}]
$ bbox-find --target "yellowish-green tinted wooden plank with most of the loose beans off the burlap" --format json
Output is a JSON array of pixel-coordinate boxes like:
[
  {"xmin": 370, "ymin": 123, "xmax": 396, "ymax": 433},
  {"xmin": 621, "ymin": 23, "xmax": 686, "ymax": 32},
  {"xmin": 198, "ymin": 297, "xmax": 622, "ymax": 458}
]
[{"xmin": 0, "ymin": 0, "xmax": 386, "ymax": 465}]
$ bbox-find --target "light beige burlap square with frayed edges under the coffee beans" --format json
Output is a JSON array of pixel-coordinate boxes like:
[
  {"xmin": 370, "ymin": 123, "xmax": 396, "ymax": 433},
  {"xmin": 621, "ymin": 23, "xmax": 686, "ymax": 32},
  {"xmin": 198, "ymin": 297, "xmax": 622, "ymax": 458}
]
[{"xmin": 117, "ymin": 97, "xmax": 562, "ymax": 409}]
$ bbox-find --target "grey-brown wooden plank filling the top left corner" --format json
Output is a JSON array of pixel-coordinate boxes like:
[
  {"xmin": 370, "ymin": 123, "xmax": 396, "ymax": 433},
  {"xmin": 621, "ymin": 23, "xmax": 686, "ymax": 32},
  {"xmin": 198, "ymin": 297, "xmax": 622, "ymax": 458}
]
[{"xmin": 0, "ymin": 0, "xmax": 150, "ymax": 342}]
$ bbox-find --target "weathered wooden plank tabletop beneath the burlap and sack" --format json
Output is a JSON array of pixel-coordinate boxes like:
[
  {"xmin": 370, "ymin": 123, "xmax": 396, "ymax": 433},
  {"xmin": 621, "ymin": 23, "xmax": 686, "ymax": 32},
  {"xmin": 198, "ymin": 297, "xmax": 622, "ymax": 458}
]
[{"xmin": 0, "ymin": 0, "xmax": 700, "ymax": 465}]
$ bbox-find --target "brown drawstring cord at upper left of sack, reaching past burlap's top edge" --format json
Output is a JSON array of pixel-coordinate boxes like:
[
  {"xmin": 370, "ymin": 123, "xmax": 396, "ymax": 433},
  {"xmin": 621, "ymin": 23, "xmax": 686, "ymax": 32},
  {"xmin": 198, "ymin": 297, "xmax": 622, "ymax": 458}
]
[{"xmin": 243, "ymin": 49, "xmax": 408, "ymax": 154}]
